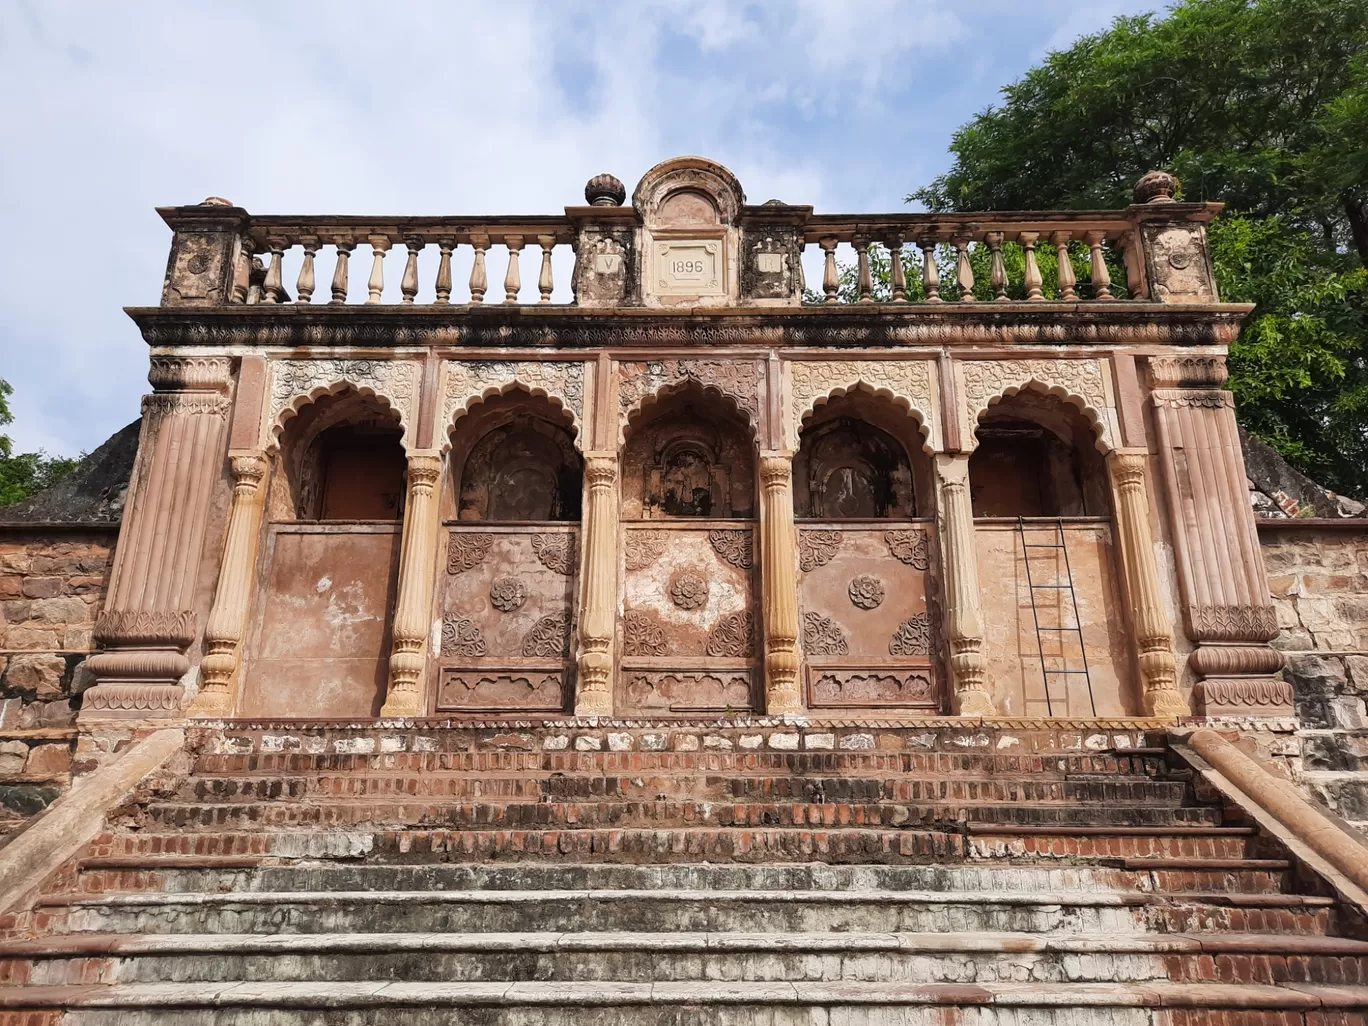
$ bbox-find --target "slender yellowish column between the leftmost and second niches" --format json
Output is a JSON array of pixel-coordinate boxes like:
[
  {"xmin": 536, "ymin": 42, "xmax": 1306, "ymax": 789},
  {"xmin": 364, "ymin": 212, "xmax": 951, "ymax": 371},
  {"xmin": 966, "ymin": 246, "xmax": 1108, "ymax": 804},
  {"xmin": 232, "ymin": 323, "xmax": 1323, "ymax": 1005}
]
[{"xmin": 380, "ymin": 449, "xmax": 442, "ymax": 717}]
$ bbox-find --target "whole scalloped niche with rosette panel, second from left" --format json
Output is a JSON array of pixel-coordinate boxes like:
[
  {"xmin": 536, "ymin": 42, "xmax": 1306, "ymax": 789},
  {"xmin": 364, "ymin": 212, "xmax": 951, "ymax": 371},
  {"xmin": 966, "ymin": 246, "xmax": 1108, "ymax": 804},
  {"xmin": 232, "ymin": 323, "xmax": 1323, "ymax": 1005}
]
[{"xmin": 432, "ymin": 387, "xmax": 584, "ymax": 715}]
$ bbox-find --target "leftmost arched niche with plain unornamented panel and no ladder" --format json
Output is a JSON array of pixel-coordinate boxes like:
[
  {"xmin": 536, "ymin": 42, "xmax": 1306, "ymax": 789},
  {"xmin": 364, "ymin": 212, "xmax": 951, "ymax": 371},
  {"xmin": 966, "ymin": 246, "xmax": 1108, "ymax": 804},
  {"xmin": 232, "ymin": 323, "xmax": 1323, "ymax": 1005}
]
[{"xmin": 241, "ymin": 383, "xmax": 406, "ymax": 718}]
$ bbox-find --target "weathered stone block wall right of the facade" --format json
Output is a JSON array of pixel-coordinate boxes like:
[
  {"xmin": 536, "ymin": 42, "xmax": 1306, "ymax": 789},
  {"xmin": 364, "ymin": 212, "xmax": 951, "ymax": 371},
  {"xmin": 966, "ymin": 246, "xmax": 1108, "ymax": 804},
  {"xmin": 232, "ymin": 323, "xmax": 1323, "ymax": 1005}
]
[{"xmin": 1259, "ymin": 520, "xmax": 1368, "ymax": 826}]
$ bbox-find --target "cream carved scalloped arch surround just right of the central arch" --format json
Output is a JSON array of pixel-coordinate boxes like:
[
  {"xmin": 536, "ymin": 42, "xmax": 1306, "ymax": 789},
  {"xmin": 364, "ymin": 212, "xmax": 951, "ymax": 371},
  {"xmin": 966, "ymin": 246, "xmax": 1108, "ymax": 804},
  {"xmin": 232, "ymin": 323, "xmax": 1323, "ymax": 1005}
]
[{"xmin": 787, "ymin": 360, "xmax": 943, "ymax": 454}]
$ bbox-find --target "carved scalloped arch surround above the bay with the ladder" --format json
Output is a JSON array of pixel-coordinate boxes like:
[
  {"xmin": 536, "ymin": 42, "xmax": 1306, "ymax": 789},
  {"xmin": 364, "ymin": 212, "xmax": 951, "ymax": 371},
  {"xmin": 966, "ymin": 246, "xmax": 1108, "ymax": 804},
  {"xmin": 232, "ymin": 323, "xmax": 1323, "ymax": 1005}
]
[{"xmin": 959, "ymin": 358, "xmax": 1120, "ymax": 453}]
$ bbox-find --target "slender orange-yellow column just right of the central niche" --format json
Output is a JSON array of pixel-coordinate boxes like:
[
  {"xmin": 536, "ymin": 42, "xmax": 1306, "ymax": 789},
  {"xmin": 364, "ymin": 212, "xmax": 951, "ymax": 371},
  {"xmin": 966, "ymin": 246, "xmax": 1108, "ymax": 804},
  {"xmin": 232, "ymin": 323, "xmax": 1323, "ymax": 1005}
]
[{"xmin": 761, "ymin": 451, "xmax": 803, "ymax": 715}]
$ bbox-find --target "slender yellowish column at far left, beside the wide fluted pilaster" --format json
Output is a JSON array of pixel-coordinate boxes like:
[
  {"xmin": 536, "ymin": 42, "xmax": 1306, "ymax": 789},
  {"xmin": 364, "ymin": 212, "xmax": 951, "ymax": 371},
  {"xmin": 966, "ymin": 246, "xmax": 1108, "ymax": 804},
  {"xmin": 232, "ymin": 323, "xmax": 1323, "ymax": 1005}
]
[{"xmin": 190, "ymin": 451, "xmax": 267, "ymax": 717}]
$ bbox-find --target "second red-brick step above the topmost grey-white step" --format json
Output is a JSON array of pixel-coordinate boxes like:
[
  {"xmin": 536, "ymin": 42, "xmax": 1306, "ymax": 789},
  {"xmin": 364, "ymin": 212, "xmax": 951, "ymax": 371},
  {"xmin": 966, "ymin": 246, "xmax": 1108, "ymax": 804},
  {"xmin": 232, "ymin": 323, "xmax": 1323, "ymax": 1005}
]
[{"xmin": 130, "ymin": 799, "xmax": 1219, "ymax": 830}]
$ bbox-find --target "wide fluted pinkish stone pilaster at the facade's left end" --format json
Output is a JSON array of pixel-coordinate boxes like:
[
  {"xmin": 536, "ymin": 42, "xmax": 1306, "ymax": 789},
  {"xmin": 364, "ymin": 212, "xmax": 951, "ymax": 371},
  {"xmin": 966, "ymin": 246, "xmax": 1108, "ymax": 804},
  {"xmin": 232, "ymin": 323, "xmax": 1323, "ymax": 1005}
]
[{"xmin": 81, "ymin": 357, "xmax": 230, "ymax": 722}]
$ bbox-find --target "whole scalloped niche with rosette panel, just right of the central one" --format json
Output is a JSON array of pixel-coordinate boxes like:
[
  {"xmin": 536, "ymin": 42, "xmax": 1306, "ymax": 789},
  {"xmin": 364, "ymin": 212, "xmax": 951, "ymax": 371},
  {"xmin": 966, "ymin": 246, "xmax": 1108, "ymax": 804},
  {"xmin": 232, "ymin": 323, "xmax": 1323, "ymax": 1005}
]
[{"xmin": 793, "ymin": 389, "xmax": 944, "ymax": 714}]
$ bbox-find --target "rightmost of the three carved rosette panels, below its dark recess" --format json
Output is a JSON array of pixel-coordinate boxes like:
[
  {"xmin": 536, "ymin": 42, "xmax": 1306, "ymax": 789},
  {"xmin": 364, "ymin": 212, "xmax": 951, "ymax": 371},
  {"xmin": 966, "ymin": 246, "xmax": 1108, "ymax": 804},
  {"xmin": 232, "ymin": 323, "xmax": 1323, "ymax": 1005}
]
[{"xmin": 798, "ymin": 523, "xmax": 940, "ymax": 713}]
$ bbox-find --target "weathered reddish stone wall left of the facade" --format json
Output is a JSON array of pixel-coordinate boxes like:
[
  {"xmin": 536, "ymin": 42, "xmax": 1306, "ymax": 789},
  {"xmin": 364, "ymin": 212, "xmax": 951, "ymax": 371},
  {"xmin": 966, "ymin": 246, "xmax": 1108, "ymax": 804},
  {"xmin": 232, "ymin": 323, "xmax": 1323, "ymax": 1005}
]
[{"xmin": 0, "ymin": 524, "xmax": 118, "ymax": 836}]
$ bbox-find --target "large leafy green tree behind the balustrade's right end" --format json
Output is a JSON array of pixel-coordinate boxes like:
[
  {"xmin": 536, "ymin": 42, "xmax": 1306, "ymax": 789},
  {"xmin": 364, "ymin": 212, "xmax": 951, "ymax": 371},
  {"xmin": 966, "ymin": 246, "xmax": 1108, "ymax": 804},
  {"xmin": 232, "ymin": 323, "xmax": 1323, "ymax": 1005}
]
[{"xmin": 908, "ymin": 0, "xmax": 1368, "ymax": 495}]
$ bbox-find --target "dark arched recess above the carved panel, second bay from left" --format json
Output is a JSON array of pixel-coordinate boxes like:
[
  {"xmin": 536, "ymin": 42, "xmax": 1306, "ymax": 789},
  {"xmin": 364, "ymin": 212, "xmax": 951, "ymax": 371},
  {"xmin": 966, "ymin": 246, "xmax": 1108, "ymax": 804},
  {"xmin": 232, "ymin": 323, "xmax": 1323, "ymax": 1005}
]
[{"xmin": 457, "ymin": 417, "xmax": 583, "ymax": 521}]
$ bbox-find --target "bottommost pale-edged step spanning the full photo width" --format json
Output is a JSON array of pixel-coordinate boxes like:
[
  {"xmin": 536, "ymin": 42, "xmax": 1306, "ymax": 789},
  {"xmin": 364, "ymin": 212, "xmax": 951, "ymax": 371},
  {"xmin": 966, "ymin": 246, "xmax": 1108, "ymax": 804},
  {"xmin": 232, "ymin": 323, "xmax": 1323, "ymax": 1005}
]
[{"xmin": 0, "ymin": 981, "xmax": 1368, "ymax": 1026}]
